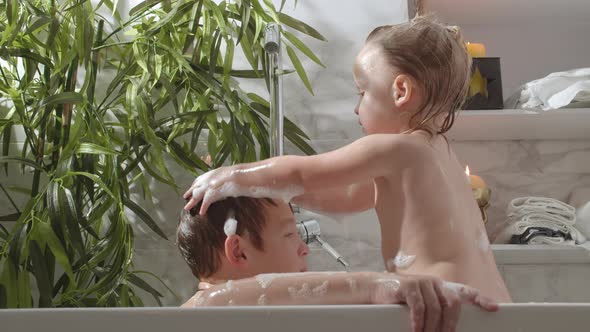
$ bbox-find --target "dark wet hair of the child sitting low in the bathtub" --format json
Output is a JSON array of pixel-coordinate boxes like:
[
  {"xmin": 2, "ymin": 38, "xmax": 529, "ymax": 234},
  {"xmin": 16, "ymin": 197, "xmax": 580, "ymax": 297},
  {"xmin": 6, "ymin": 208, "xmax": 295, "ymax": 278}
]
[{"xmin": 176, "ymin": 197, "xmax": 277, "ymax": 279}]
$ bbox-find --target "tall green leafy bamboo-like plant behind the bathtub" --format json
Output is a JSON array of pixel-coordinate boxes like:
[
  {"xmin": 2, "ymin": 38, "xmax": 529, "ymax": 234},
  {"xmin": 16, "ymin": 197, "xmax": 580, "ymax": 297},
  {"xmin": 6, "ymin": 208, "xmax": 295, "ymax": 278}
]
[{"xmin": 0, "ymin": 0, "xmax": 324, "ymax": 308}]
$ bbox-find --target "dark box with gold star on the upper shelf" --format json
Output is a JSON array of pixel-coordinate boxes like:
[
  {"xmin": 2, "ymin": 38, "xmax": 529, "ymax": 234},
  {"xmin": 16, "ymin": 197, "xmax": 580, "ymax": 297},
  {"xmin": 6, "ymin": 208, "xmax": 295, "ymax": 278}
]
[{"xmin": 464, "ymin": 57, "xmax": 504, "ymax": 110}]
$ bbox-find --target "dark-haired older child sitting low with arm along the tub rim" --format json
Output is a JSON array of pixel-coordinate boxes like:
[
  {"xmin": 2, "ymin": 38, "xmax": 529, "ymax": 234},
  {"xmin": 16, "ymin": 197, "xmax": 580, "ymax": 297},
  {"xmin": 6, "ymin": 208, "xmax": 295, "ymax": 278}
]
[{"xmin": 176, "ymin": 197, "xmax": 497, "ymax": 331}]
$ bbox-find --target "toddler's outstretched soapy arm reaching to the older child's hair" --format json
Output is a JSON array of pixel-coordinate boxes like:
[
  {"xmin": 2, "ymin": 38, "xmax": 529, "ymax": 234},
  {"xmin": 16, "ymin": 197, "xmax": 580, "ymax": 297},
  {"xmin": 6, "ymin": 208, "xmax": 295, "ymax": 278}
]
[{"xmin": 184, "ymin": 134, "xmax": 404, "ymax": 214}]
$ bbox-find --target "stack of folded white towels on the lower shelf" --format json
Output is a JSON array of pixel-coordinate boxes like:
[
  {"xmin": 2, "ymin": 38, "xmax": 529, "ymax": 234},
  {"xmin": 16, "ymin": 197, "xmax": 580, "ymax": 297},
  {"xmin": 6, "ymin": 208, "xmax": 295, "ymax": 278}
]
[{"xmin": 495, "ymin": 197, "xmax": 586, "ymax": 245}]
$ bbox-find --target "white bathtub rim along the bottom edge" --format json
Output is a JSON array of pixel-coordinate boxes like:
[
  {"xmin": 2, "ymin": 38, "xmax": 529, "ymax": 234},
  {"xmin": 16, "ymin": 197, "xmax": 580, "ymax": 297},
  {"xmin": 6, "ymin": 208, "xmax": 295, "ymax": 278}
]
[{"xmin": 0, "ymin": 303, "xmax": 590, "ymax": 332}]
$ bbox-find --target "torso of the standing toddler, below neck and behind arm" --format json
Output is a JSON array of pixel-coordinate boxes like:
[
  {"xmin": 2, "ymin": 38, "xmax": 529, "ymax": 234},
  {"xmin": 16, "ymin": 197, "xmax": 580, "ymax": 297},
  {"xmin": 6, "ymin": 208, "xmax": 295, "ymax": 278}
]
[{"xmin": 375, "ymin": 132, "xmax": 511, "ymax": 302}]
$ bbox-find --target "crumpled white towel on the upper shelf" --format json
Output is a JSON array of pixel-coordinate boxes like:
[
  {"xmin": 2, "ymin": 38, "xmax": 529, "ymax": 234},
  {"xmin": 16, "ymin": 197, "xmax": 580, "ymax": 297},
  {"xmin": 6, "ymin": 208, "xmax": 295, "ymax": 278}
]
[{"xmin": 520, "ymin": 68, "xmax": 590, "ymax": 110}]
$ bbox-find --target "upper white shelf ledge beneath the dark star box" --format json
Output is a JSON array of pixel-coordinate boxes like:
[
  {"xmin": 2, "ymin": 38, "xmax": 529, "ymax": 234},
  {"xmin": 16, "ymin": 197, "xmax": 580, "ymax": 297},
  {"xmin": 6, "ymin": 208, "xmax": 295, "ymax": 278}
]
[{"xmin": 449, "ymin": 108, "xmax": 590, "ymax": 141}]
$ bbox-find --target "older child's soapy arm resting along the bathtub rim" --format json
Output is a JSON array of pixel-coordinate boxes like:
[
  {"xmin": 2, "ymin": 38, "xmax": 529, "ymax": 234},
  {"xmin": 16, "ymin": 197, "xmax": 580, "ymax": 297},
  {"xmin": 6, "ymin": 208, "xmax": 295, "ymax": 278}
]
[{"xmin": 193, "ymin": 272, "xmax": 498, "ymax": 331}]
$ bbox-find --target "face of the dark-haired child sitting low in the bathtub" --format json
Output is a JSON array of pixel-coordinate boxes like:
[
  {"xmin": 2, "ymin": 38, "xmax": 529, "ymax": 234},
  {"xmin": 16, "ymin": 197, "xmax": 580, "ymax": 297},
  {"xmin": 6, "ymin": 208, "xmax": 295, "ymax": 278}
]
[{"xmin": 249, "ymin": 200, "xmax": 309, "ymax": 274}]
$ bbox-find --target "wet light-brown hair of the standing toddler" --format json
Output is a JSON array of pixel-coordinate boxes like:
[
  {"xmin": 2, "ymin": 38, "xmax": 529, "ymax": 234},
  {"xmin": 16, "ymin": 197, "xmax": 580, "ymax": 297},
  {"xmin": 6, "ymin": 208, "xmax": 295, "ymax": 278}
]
[{"xmin": 366, "ymin": 15, "xmax": 471, "ymax": 135}]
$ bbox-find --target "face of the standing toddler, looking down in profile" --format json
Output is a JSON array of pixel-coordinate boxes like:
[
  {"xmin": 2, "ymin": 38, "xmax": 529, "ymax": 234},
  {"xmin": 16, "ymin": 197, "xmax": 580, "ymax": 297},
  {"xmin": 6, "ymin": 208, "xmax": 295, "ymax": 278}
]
[{"xmin": 353, "ymin": 43, "xmax": 401, "ymax": 135}]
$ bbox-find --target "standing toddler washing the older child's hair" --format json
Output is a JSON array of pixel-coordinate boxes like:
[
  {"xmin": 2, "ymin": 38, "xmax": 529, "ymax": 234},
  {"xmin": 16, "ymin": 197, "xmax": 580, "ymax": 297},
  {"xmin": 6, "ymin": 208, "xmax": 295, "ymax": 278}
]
[{"xmin": 184, "ymin": 16, "xmax": 511, "ymax": 302}]
